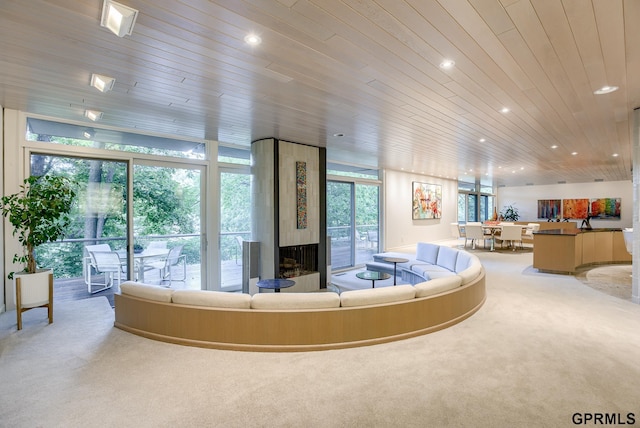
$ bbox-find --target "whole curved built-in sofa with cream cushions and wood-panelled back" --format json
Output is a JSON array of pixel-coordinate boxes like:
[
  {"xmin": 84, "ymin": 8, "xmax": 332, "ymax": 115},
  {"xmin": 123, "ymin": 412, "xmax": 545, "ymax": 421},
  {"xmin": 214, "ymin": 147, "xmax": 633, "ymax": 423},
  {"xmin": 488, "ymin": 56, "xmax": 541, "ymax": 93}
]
[{"xmin": 115, "ymin": 243, "xmax": 485, "ymax": 351}]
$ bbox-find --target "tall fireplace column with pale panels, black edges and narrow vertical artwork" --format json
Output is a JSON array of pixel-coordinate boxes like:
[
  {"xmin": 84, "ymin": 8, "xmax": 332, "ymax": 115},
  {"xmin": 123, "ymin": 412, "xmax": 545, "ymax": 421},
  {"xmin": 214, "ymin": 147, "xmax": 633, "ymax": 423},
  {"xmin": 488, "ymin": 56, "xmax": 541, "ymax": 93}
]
[{"xmin": 251, "ymin": 138, "xmax": 328, "ymax": 292}]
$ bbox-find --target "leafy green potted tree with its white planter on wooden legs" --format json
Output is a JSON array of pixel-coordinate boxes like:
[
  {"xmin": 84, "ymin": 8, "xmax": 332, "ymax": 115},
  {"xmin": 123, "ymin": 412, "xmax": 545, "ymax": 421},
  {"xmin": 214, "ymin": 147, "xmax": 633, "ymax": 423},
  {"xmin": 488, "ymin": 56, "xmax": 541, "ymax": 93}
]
[{"xmin": 2, "ymin": 175, "xmax": 76, "ymax": 329}]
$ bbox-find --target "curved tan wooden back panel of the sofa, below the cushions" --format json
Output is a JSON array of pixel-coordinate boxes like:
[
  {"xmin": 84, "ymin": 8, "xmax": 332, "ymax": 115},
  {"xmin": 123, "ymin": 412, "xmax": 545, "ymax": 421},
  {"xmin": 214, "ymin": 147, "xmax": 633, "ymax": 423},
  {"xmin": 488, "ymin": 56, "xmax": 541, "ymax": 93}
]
[{"xmin": 115, "ymin": 270, "xmax": 486, "ymax": 352}]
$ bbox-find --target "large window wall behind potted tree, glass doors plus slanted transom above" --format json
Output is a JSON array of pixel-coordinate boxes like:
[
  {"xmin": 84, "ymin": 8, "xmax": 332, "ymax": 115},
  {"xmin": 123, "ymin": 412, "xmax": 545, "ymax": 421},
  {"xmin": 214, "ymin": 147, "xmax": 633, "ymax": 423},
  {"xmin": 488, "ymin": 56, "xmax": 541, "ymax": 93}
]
[{"xmin": 25, "ymin": 118, "xmax": 207, "ymax": 302}]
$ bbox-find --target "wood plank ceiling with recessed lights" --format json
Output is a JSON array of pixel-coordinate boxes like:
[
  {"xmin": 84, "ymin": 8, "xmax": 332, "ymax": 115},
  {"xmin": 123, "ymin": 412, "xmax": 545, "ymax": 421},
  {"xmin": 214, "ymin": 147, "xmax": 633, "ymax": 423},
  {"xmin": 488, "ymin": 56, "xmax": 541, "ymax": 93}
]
[{"xmin": 0, "ymin": 0, "xmax": 640, "ymax": 186}]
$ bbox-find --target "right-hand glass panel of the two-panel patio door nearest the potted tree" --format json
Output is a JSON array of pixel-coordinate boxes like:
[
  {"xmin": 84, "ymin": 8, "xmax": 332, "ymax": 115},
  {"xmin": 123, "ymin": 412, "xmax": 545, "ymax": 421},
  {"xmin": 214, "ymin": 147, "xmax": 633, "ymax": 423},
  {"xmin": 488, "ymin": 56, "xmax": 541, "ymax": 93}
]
[{"xmin": 133, "ymin": 161, "xmax": 204, "ymax": 289}]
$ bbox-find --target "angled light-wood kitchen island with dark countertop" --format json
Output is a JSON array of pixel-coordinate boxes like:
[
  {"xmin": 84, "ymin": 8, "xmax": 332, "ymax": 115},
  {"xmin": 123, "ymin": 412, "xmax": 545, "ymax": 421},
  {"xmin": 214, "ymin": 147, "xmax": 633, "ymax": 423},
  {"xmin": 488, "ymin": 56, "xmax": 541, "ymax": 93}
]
[{"xmin": 533, "ymin": 228, "xmax": 631, "ymax": 274}]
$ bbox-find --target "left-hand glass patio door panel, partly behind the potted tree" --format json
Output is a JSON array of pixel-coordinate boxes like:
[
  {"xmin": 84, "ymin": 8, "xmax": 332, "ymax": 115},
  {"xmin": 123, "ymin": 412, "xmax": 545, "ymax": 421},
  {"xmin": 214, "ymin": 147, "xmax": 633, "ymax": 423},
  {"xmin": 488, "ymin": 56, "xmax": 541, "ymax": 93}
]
[{"xmin": 30, "ymin": 154, "xmax": 129, "ymax": 300}]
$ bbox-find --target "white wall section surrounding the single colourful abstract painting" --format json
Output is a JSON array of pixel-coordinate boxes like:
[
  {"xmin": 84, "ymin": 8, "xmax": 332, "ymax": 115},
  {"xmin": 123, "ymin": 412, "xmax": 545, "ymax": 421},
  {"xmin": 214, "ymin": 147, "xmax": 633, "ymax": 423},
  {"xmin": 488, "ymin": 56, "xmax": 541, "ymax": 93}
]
[{"xmin": 380, "ymin": 171, "xmax": 458, "ymax": 251}]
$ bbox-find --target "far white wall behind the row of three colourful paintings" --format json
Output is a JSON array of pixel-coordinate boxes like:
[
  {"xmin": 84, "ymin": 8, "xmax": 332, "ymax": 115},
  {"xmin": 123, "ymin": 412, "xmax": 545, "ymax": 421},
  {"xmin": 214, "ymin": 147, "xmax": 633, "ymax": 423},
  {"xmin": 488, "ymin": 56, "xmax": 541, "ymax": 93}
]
[{"xmin": 497, "ymin": 180, "xmax": 633, "ymax": 228}]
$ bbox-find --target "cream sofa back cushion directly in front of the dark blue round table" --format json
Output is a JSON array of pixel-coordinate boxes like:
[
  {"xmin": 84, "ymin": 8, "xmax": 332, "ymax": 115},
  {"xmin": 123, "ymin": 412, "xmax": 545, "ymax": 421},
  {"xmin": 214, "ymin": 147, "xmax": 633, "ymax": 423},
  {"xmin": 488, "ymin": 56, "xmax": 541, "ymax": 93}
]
[{"xmin": 251, "ymin": 291, "xmax": 340, "ymax": 309}]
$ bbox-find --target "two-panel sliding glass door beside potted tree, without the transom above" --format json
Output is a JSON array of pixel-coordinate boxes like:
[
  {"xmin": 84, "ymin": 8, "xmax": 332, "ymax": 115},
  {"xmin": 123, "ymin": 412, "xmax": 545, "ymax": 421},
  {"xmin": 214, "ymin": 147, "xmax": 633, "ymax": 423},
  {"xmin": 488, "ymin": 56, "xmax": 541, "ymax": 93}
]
[{"xmin": 30, "ymin": 153, "xmax": 204, "ymax": 303}]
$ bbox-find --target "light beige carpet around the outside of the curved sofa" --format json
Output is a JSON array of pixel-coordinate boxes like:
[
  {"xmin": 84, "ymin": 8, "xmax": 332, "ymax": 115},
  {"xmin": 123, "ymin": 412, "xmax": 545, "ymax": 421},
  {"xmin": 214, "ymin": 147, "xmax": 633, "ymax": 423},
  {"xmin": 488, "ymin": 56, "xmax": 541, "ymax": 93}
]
[{"xmin": 0, "ymin": 247, "xmax": 640, "ymax": 427}]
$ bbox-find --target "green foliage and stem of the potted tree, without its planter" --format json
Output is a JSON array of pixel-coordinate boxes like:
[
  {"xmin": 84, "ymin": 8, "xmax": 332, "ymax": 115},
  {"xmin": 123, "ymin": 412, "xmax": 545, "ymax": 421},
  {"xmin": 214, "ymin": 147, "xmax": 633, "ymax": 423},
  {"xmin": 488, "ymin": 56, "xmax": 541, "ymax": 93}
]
[{"xmin": 2, "ymin": 175, "xmax": 76, "ymax": 279}]
